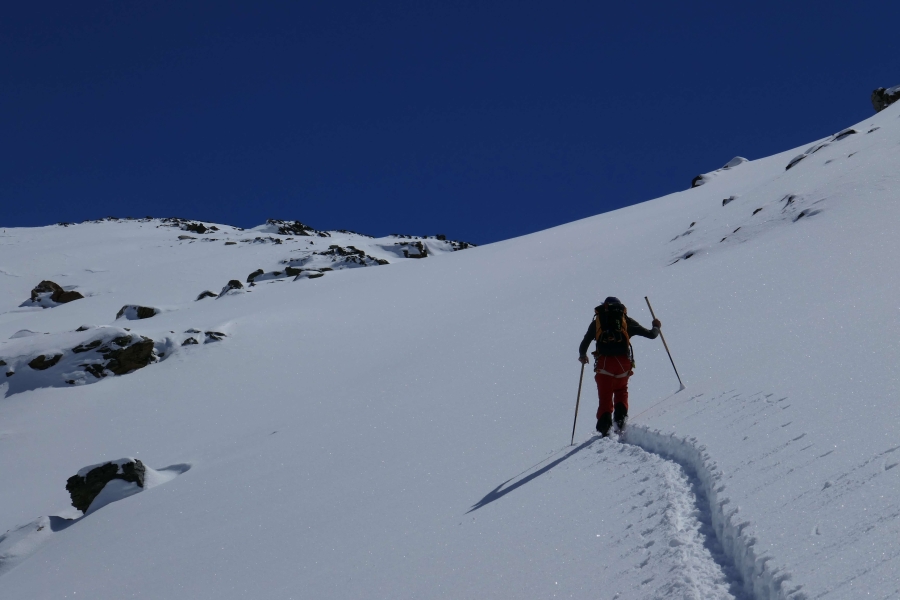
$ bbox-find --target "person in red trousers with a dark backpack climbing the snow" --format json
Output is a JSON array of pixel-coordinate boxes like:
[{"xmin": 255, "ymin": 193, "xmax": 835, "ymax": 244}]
[{"xmin": 578, "ymin": 296, "xmax": 662, "ymax": 437}]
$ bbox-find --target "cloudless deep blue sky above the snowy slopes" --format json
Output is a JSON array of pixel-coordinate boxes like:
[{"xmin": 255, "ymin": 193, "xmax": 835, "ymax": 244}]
[{"xmin": 0, "ymin": 0, "xmax": 900, "ymax": 243}]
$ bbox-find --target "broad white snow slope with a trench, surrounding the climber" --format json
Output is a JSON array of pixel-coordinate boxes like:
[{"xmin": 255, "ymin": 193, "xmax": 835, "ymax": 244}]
[{"xmin": 0, "ymin": 105, "xmax": 900, "ymax": 600}]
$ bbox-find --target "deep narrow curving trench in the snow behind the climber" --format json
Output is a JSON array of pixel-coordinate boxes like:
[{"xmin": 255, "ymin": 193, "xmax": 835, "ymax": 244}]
[{"xmin": 623, "ymin": 424, "xmax": 808, "ymax": 600}]
